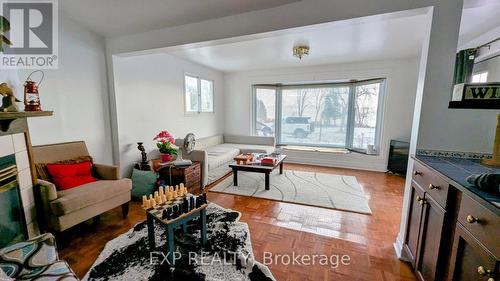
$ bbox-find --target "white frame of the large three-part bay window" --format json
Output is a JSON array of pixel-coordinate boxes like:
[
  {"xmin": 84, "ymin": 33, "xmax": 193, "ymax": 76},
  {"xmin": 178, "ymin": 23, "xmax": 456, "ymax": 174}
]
[{"xmin": 254, "ymin": 78, "xmax": 387, "ymax": 154}]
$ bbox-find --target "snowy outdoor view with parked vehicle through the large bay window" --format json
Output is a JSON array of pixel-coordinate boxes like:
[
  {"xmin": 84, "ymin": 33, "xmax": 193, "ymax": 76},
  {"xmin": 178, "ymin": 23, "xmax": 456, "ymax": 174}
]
[{"xmin": 255, "ymin": 81, "xmax": 382, "ymax": 149}]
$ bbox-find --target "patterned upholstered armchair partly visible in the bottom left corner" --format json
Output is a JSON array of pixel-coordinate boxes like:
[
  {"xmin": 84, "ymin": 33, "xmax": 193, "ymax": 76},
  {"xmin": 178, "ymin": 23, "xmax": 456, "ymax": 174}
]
[{"xmin": 0, "ymin": 233, "xmax": 78, "ymax": 281}]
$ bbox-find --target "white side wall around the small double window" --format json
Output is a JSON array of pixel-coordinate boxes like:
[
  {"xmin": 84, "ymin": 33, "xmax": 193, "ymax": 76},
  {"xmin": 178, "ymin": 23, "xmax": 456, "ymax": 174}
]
[{"xmin": 113, "ymin": 54, "xmax": 224, "ymax": 176}]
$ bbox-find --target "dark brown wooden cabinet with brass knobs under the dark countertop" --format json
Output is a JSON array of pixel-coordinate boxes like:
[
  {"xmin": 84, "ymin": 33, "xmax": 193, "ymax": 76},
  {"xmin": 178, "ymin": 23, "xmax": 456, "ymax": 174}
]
[{"xmin": 403, "ymin": 160, "xmax": 500, "ymax": 281}]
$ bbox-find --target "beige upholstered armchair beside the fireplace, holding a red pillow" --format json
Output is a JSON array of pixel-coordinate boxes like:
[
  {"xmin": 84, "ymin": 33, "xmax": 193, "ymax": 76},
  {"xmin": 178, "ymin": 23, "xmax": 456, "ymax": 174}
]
[{"xmin": 33, "ymin": 141, "xmax": 132, "ymax": 232}]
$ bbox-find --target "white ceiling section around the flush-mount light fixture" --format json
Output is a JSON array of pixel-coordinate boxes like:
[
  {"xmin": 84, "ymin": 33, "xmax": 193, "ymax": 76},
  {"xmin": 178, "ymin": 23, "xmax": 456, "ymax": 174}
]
[{"xmin": 170, "ymin": 15, "xmax": 425, "ymax": 72}]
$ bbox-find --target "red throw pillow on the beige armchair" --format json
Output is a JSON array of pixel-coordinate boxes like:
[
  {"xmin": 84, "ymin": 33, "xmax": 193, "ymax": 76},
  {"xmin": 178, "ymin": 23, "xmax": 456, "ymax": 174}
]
[{"xmin": 47, "ymin": 161, "xmax": 97, "ymax": 190}]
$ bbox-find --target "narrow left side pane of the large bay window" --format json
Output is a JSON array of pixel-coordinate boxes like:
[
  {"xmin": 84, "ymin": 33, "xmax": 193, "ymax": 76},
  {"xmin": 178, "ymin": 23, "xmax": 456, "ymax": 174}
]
[{"xmin": 255, "ymin": 88, "xmax": 276, "ymax": 136}]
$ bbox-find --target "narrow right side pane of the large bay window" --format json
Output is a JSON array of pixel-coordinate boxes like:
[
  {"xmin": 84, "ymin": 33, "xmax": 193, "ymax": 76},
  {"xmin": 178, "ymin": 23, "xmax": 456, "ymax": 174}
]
[{"xmin": 353, "ymin": 83, "xmax": 380, "ymax": 149}]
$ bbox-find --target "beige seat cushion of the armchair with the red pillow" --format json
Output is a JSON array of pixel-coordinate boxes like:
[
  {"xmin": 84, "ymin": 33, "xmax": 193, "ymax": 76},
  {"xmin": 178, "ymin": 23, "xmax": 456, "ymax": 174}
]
[{"xmin": 50, "ymin": 179, "xmax": 132, "ymax": 216}]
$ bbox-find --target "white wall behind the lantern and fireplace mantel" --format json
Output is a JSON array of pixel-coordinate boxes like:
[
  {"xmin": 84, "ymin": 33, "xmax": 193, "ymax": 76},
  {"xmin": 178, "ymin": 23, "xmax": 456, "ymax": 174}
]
[{"xmin": 0, "ymin": 13, "xmax": 112, "ymax": 164}]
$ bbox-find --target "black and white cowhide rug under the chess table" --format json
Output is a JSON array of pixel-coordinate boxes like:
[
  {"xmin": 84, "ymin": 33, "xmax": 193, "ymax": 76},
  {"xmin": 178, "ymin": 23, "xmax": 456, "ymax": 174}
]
[{"xmin": 83, "ymin": 203, "xmax": 275, "ymax": 281}]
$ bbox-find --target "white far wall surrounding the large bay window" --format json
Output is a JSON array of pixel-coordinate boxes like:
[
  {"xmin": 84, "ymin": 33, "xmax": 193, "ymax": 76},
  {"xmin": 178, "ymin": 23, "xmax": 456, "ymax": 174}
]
[{"xmin": 224, "ymin": 58, "xmax": 418, "ymax": 171}]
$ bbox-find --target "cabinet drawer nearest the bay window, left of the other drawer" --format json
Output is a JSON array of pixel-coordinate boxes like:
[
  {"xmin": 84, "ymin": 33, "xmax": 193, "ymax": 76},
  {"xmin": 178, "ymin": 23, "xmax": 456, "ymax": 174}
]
[{"xmin": 412, "ymin": 161, "xmax": 449, "ymax": 209}]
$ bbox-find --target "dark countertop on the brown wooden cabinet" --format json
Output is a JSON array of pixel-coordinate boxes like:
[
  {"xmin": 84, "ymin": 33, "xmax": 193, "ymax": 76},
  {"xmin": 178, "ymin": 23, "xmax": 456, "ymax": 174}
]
[{"xmin": 414, "ymin": 155, "xmax": 500, "ymax": 211}]
